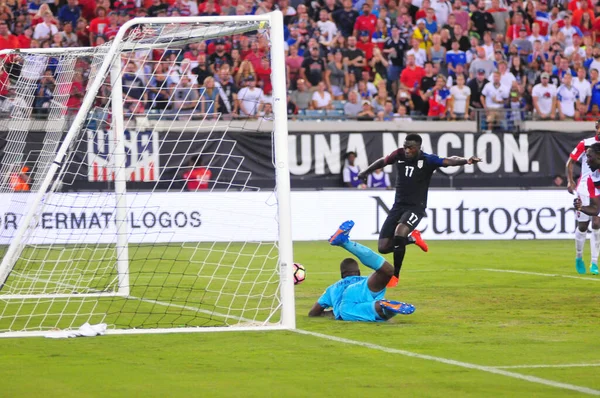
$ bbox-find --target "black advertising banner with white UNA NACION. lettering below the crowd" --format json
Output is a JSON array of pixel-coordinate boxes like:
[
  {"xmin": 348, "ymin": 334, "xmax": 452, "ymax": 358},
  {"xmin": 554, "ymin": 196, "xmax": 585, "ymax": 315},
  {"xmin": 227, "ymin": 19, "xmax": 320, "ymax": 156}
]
[{"xmin": 0, "ymin": 130, "xmax": 593, "ymax": 190}]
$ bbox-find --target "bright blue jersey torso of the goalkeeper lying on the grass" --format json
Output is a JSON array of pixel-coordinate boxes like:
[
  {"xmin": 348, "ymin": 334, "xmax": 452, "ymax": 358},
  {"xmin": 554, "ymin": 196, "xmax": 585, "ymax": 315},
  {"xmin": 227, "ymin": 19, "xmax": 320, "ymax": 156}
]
[{"xmin": 339, "ymin": 278, "xmax": 385, "ymax": 322}]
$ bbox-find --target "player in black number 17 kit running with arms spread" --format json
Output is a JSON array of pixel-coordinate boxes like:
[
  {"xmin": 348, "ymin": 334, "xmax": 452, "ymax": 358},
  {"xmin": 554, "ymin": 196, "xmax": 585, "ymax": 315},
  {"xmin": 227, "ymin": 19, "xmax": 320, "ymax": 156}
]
[{"xmin": 358, "ymin": 134, "xmax": 481, "ymax": 287}]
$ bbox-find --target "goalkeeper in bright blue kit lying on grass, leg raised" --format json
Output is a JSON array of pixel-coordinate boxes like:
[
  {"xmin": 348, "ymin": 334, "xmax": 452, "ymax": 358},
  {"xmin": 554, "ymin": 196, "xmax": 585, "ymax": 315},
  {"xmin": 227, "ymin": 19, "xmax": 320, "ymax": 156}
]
[{"xmin": 308, "ymin": 221, "xmax": 415, "ymax": 322}]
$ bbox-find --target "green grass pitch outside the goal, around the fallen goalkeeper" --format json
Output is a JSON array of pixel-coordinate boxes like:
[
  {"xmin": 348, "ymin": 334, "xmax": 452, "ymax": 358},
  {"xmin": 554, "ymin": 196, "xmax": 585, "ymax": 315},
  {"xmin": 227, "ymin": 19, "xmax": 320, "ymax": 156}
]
[{"xmin": 0, "ymin": 241, "xmax": 600, "ymax": 398}]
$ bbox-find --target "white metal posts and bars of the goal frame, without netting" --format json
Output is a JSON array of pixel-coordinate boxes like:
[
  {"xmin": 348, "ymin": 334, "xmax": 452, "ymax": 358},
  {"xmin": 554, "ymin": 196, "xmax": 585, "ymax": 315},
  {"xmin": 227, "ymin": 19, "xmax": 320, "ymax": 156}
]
[{"xmin": 0, "ymin": 11, "xmax": 296, "ymax": 335}]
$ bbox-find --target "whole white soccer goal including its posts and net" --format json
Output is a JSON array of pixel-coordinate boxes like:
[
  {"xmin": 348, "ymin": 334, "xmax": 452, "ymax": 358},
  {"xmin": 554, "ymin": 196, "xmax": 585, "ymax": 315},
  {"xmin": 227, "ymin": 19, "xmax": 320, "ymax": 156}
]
[{"xmin": 0, "ymin": 12, "xmax": 295, "ymax": 337}]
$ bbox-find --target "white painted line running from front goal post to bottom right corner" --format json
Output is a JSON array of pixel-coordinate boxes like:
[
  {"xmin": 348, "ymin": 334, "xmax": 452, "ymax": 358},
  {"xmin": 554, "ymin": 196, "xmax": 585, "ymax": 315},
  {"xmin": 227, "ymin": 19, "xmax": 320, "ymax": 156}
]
[{"xmin": 291, "ymin": 329, "xmax": 600, "ymax": 396}]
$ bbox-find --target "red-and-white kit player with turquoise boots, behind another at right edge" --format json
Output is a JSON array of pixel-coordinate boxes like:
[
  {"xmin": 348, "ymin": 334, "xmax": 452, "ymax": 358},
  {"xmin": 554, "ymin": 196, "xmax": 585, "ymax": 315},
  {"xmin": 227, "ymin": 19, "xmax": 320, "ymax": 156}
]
[{"xmin": 566, "ymin": 120, "xmax": 600, "ymax": 275}]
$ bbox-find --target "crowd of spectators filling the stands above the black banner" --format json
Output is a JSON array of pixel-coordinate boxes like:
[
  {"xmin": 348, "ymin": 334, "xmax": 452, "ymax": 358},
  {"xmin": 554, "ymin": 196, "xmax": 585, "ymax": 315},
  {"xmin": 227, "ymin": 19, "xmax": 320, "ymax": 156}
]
[{"xmin": 0, "ymin": 0, "xmax": 600, "ymax": 121}]
